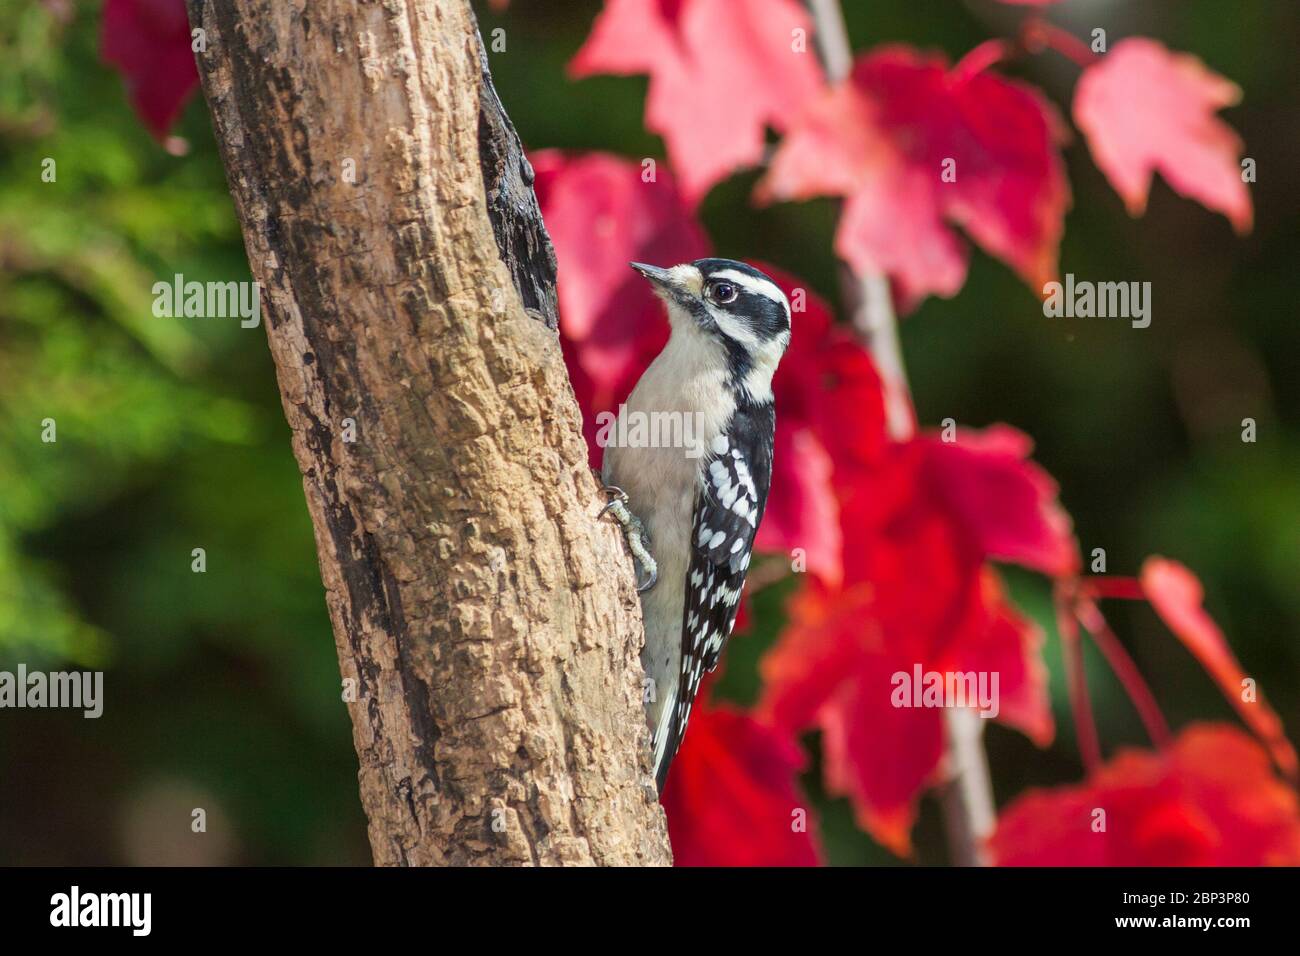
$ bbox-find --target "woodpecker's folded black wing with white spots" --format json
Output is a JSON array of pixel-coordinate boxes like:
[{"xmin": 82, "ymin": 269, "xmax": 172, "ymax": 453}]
[{"xmin": 657, "ymin": 403, "xmax": 776, "ymax": 790}]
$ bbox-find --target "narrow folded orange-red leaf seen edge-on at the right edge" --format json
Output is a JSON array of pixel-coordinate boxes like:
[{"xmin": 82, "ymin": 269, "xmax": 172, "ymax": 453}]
[{"xmin": 1140, "ymin": 557, "xmax": 1296, "ymax": 779}]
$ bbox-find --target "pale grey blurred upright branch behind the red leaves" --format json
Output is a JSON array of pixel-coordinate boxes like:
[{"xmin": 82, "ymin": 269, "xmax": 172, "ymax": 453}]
[{"xmin": 807, "ymin": 0, "xmax": 996, "ymax": 866}]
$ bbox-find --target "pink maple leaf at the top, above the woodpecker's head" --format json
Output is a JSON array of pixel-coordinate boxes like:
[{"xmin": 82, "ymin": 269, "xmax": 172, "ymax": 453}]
[{"xmin": 569, "ymin": 0, "xmax": 822, "ymax": 204}]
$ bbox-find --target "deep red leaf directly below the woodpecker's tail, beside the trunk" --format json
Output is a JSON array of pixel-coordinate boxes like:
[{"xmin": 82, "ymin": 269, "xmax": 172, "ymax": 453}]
[{"xmin": 663, "ymin": 695, "xmax": 823, "ymax": 866}]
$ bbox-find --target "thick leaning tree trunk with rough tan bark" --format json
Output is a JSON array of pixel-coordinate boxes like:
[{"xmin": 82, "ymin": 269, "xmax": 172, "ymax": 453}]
[{"xmin": 189, "ymin": 0, "xmax": 670, "ymax": 865}]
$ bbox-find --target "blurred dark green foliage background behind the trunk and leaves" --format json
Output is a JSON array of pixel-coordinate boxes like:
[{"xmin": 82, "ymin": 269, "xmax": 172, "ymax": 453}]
[{"xmin": 0, "ymin": 0, "xmax": 1300, "ymax": 864}]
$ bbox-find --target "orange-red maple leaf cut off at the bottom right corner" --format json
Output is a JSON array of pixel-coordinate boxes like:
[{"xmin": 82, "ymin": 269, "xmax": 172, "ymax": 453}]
[{"xmin": 989, "ymin": 723, "xmax": 1300, "ymax": 866}]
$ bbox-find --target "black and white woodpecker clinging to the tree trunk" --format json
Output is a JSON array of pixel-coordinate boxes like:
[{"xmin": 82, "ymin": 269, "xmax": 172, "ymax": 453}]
[{"xmin": 597, "ymin": 259, "xmax": 792, "ymax": 793}]
